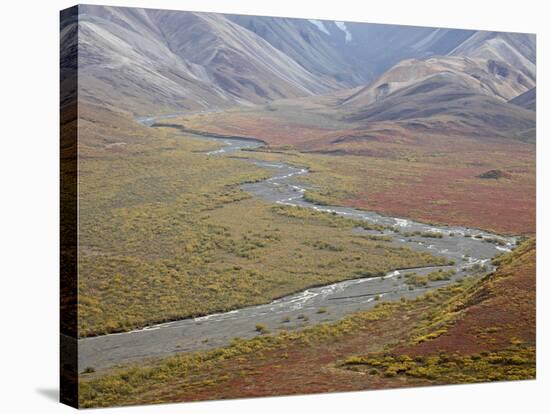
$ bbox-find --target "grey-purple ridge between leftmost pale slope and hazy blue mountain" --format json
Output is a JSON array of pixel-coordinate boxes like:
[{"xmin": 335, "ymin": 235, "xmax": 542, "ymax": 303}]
[{"xmin": 149, "ymin": 10, "xmax": 336, "ymax": 98}]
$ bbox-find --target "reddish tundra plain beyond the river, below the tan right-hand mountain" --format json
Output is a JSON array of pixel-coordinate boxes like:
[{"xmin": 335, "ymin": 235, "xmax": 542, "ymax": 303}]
[{"xmin": 170, "ymin": 100, "xmax": 536, "ymax": 234}]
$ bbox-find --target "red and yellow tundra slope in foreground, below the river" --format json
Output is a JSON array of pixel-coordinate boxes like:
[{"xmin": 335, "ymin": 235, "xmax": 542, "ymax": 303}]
[{"xmin": 80, "ymin": 239, "xmax": 536, "ymax": 407}]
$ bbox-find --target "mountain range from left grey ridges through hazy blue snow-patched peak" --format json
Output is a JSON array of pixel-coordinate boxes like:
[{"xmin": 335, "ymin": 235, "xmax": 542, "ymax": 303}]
[{"xmin": 66, "ymin": 5, "xmax": 492, "ymax": 115}]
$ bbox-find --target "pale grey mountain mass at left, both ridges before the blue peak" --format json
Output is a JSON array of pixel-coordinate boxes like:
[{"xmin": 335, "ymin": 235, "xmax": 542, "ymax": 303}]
[{"xmin": 70, "ymin": 5, "xmax": 339, "ymax": 114}]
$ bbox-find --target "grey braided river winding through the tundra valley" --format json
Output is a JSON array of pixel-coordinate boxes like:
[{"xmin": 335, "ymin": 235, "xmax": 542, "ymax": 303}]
[{"xmin": 79, "ymin": 115, "xmax": 516, "ymax": 370}]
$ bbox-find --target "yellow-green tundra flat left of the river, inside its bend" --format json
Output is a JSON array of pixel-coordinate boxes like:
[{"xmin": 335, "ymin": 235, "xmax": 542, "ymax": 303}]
[{"xmin": 78, "ymin": 124, "xmax": 446, "ymax": 336}]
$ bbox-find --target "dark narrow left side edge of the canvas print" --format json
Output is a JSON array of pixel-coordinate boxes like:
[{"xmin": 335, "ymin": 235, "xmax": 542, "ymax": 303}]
[{"xmin": 60, "ymin": 6, "xmax": 78, "ymax": 407}]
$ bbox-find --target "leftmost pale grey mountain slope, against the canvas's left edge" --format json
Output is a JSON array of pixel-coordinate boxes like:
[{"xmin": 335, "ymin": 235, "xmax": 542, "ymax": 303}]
[{"xmin": 71, "ymin": 6, "xmax": 229, "ymax": 113}]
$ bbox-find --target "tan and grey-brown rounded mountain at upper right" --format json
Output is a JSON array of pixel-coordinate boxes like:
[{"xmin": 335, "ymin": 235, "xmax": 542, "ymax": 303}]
[{"xmin": 340, "ymin": 32, "xmax": 535, "ymax": 141}]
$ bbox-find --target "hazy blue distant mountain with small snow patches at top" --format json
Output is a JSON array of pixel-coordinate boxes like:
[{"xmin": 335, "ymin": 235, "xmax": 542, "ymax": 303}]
[{"xmin": 231, "ymin": 15, "xmax": 475, "ymax": 87}]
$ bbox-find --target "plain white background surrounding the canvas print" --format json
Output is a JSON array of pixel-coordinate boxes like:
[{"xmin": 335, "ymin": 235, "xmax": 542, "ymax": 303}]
[{"xmin": 0, "ymin": 0, "xmax": 550, "ymax": 414}]
